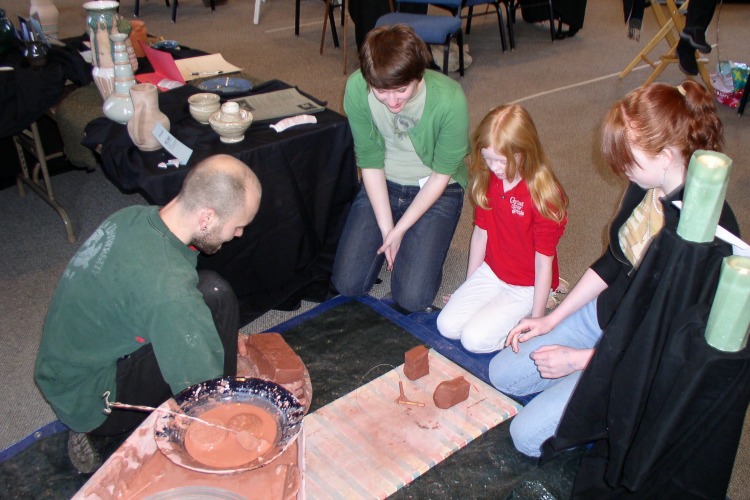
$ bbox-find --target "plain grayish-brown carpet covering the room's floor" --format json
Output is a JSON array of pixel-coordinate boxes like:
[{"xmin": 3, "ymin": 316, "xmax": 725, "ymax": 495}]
[{"xmin": 0, "ymin": 0, "xmax": 750, "ymax": 498}]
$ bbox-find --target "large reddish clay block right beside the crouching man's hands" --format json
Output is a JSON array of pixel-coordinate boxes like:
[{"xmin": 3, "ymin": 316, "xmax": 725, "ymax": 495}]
[{"xmin": 246, "ymin": 333, "xmax": 305, "ymax": 384}]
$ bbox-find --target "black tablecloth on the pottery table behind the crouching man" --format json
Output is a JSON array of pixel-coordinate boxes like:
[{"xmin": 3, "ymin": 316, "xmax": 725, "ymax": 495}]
[{"xmin": 84, "ymin": 80, "xmax": 358, "ymax": 322}]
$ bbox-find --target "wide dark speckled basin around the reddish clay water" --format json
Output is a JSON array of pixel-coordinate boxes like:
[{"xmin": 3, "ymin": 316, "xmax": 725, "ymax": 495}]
[{"xmin": 154, "ymin": 377, "xmax": 305, "ymax": 474}]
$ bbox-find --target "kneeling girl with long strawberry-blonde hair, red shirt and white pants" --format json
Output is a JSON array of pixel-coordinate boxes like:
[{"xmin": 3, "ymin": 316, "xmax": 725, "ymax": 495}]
[{"xmin": 437, "ymin": 105, "xmax": 568, "ymax": 353}]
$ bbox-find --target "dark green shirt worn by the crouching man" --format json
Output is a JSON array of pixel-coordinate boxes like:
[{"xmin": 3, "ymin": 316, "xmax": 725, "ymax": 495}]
[{"xmin": 35, "ymin": 206, "xmax": 224, "ymax": 432}]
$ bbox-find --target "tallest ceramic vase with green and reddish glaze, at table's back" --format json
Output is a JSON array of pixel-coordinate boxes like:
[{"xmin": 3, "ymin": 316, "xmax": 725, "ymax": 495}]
[{"xmin": 83, "ymin": 0, "xmax": 120, "ymax": 100}]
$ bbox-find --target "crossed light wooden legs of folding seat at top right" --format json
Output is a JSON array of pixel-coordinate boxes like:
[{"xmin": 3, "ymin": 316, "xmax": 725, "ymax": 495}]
[{"xmin": 620, "ymin": 0, "xmax": 714, "ymax": 92}]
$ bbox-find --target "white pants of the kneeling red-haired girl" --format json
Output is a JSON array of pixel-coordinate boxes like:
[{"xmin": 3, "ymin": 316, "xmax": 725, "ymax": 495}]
[{"xmin": 437, "ymin": 262, "xmax": 534, "ymax": 353}]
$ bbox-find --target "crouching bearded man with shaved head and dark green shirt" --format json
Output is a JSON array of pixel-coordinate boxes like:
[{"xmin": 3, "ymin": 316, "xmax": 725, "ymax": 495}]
[{"xmin": 34, "ymin": 155, "xmax": 261, "ymax": 472}]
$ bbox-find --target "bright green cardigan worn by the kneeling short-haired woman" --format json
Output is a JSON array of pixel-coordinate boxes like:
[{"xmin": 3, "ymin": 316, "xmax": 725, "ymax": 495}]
[{"xmin": 344, "ymin": 70, "xmax": 469, "ymax": 188}]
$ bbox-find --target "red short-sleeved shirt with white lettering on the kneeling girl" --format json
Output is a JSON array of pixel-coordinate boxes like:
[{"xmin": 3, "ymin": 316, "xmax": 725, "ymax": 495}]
[{"xmin": 474, "ymin": 176, "xmax": 568, "ymax": 289}]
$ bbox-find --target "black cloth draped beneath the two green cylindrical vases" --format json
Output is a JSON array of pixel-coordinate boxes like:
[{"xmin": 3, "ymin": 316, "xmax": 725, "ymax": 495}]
[{"xmin": 544, "ymin": 228, "xmax": 750, "ymax": 499}]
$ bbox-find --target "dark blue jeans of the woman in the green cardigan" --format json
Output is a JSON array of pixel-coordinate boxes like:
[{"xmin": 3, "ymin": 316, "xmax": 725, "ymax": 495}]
[{"xmin": 332, "ymin": 182, "xmax": 464, "ymax": 311}]
